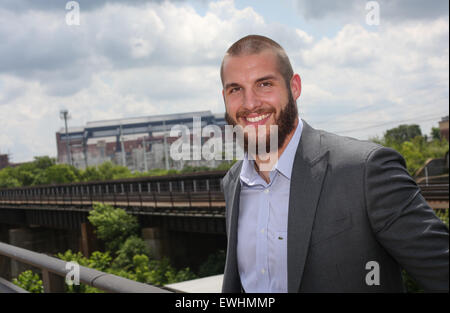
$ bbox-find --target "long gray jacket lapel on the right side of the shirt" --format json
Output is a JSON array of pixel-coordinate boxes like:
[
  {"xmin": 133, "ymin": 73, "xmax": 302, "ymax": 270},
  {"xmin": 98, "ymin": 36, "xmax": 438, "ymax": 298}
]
[{"xmin": 287, "ymin": 121, "xmax": 328, "ymax": 292}]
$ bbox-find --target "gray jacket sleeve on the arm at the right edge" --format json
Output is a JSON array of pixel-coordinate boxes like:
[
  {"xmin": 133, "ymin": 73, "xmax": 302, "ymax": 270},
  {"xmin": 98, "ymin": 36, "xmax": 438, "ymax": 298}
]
[{"xmin": 364, "ymin": 147, "xmax": 449, "ymax": 291}]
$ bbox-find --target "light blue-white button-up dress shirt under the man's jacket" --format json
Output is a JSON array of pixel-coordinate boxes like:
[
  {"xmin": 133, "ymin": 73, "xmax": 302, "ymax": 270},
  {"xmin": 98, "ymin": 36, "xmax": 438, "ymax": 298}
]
[{"xmin": 237, "ymin": 119, "xmax": 303, "ymax": 292}]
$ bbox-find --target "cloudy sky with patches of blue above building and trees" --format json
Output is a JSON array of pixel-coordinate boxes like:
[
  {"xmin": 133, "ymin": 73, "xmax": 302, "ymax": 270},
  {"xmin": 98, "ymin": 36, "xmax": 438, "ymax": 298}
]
[{"xmin": 0, "ymin": 0, "xmax": 449, "ymax": 162}]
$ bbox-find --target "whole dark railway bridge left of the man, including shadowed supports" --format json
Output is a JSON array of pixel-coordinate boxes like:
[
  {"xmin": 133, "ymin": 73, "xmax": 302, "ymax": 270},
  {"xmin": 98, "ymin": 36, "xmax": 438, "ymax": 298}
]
[{"xmin": 0, "ymin": 171, "xmax": 226, "ymax": 276}]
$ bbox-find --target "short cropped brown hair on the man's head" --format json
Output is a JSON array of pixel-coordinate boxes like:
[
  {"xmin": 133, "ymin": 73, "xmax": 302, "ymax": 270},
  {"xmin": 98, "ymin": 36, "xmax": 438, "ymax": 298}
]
[{"xmin": 220, "ymin": 35, "xmax": 294, "ymax": 88}]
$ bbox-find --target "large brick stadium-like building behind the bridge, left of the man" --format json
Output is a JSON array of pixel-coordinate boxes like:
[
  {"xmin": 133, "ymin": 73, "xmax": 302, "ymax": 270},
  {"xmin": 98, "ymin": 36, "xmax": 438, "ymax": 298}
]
[{"xmin": 56, "ymin": 111, "xmax": 226, "ymax": 172}]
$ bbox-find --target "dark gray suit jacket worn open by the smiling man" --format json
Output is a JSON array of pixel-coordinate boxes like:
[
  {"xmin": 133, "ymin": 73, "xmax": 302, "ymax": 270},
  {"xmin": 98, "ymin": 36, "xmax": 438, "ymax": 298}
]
[{"xmin": 222, "ymin": 122, "xmax": 449, "ymax": 292}]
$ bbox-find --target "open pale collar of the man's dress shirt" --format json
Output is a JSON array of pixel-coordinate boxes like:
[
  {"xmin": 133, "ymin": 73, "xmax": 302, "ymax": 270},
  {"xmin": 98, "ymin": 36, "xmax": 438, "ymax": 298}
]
[{"xmin": 239, "ymin": 118, "xmax": 303, "ymax": 185}]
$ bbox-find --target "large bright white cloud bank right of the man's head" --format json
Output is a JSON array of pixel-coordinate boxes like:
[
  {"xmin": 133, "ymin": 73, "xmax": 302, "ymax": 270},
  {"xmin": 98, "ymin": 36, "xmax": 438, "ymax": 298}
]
[{"xmin": 300, "ymin": 18, "xmax": 449, "ymax": 138}]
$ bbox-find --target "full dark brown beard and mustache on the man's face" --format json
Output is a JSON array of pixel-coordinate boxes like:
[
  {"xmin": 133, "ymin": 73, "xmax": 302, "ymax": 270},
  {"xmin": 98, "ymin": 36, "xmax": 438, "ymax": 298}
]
[{"xmin": 225, "ymin": 90, "xmax": 298, "ymax": 152}]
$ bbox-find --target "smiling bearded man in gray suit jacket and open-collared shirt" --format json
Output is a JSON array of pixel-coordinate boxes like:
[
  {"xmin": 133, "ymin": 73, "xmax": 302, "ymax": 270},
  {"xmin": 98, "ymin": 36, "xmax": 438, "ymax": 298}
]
[{"xmin": 221, "ymin": 35, "xmax": 448, "ymax": 292}]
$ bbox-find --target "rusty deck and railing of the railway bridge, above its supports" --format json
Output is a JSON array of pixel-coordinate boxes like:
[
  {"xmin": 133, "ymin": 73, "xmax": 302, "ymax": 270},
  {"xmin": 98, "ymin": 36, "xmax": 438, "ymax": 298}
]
[{"xmin": 0, "ymin": 171, "xmax": 225, "ymax": 234}]
